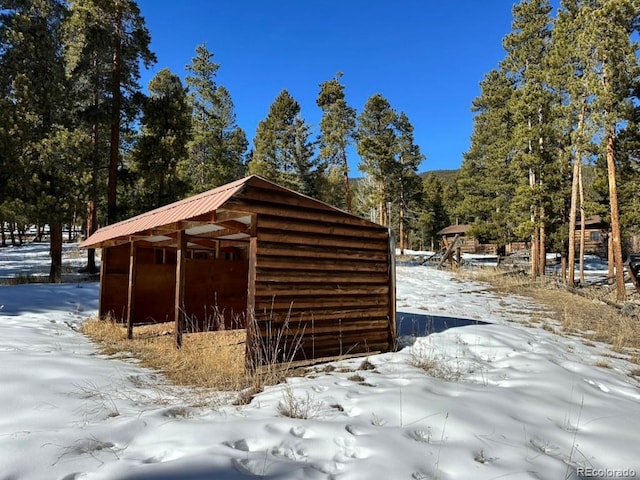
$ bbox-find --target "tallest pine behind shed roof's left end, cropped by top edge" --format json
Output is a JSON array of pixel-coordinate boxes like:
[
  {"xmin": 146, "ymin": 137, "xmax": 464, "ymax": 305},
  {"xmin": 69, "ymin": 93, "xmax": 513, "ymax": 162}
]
[{"xmin": 67, "ymin": 0, "xmax": 156, "ymax": 223}]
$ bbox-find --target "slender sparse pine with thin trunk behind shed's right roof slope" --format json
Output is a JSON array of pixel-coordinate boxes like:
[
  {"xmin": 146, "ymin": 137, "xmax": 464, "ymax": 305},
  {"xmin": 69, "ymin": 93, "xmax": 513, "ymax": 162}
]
[{"xmin": 316, "ymin": 72, "xmax": 356, "ymax": 212}]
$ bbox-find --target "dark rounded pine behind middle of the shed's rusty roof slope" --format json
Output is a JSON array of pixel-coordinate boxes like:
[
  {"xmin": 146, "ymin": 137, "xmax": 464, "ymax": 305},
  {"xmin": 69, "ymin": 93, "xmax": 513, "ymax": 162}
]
[{"xmin": 133, "ymin": 68, "xmax": 191, "ymax": 211}]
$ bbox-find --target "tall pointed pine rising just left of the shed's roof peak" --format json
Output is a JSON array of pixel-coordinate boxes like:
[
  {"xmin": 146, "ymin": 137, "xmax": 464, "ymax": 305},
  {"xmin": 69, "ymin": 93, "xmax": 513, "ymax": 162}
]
[{"xmin": 185, "ymin": 45, "xmax": 248, "ymax": 193}]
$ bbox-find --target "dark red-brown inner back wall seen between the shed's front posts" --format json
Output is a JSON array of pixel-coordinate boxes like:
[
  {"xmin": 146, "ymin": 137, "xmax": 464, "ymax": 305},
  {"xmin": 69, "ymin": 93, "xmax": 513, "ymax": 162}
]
[{"xmin": 101, "ymin": 240, "xmax": 249, "ymax": 332}]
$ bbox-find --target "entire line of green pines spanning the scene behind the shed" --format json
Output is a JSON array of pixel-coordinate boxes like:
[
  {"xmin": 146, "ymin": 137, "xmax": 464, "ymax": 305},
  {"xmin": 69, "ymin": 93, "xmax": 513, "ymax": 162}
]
[{"xmin": 0, "ymin": 0, "xmax": 640, "ymax": 302}]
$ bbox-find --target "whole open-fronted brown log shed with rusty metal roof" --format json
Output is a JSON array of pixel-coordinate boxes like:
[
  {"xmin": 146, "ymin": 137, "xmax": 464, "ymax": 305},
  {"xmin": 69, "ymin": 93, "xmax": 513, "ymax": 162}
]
[{"xmin": 82, "ymin": 176, "xmax": 396, "ymax": 365}]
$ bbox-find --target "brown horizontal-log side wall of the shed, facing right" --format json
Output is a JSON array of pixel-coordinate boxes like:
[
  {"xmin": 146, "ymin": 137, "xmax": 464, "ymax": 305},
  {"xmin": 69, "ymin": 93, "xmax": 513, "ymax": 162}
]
[{"xmin": 228, "ymin": 188, "xmax": 395, "ymax": 360}]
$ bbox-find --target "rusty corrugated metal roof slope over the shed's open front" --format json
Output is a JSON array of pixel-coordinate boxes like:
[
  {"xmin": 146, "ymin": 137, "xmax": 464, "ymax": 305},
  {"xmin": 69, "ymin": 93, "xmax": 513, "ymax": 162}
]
[{"xmin": 80, "ymin": 176, "xmax": 254, "ymax": 247}]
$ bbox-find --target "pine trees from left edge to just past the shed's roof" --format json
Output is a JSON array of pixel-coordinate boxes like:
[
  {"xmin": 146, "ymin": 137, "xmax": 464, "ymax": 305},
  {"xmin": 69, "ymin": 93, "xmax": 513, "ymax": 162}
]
[{"xmin": 0, "ymin": 0, "xmax": 424, "ymax": 281}]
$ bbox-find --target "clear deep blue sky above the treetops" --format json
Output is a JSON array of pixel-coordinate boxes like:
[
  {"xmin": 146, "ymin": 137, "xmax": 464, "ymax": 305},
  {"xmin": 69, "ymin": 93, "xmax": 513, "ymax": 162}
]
[{"xmin": 138, "ymin": 0, "xmax": 514, "ymax": 173}]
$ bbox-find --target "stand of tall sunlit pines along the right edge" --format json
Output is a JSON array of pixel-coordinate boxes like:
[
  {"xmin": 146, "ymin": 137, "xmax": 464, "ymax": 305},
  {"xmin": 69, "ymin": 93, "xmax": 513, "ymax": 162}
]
[{"xmin": 420, "ymin": 0, "xmax": 640, "ymax": 298}]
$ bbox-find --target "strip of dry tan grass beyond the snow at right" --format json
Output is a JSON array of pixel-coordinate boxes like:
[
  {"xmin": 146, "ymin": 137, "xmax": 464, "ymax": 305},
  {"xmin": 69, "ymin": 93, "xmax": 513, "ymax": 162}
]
[{"xmin": 461, "ymin": 270, "xmax": 640, "ymax": 363}]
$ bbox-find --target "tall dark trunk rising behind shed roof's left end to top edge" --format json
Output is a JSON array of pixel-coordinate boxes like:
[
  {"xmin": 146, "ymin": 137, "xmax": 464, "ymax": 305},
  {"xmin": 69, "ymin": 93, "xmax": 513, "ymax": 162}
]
[{"xmin": 107, "ymin": 0, "xmax": 122, "ymax": 224}]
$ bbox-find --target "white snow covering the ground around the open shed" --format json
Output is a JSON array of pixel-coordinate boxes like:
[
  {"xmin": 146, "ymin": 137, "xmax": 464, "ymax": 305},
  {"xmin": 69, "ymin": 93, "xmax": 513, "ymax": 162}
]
[{"xmin": 0, "ymin": 246, "xmax": 640, "ymax": 480}]
